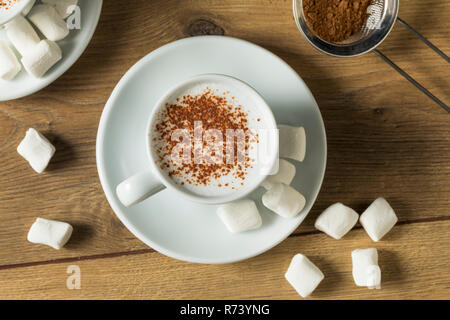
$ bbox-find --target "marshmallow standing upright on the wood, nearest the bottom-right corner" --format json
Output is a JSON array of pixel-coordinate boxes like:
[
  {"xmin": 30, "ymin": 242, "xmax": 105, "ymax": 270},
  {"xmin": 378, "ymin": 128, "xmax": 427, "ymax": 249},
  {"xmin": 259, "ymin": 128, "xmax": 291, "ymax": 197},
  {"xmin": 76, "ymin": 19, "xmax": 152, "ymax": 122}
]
[{"xmin": 352, "ymin": 248, "xmax": 381, "ymax": 289}]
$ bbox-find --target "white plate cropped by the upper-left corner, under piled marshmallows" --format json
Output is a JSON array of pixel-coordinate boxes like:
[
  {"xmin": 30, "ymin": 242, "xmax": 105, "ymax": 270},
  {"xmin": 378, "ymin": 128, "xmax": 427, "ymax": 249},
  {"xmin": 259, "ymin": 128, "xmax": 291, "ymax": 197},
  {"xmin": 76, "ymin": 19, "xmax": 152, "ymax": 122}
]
[{"xmin": 0, "ymin": 0, "xmax": 103, "ymax": 101}]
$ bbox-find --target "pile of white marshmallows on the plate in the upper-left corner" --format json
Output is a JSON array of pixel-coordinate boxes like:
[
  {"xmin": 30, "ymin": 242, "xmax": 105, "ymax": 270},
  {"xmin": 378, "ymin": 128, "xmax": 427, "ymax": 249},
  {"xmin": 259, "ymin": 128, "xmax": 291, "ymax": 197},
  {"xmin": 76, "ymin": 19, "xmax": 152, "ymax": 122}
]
[{"xmin": 0, "ymin": 0, "xmax": 78, "ymax": 80}]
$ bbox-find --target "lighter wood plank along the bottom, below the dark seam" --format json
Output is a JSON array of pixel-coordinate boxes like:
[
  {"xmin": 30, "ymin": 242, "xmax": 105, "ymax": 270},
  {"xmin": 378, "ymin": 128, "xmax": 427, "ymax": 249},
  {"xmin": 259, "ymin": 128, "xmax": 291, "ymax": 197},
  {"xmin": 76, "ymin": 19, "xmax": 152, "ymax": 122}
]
[{"xmin": 0, "ymin": 220, "xmax": 450, "ymax": 299}]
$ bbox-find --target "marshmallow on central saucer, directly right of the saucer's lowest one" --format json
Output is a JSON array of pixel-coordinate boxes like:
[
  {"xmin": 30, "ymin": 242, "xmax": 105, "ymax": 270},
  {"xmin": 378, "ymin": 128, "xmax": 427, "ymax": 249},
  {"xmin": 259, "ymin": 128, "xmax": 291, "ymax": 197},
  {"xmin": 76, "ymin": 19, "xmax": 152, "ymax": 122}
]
[{"xmin": 262, "ymin": 183, "xmax": 306, "ymax": 218}]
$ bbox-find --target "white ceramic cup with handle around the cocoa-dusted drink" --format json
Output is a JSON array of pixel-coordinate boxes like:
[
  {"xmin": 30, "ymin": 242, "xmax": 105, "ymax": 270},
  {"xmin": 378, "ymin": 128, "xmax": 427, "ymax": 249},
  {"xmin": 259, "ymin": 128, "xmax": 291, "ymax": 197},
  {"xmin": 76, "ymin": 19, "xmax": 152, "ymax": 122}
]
[{"xmin": 116, "ymin": 74, "xmax": 278, "ymax": 207}]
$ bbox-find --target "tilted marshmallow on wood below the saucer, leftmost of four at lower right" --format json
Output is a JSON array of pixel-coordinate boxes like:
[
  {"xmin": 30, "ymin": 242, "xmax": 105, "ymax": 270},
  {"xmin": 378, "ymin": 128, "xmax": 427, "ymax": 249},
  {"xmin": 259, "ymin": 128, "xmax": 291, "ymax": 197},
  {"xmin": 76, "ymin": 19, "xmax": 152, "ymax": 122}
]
[{"xmin": 284, "ymin": 253, "xmax": 325, "ymax": 298}]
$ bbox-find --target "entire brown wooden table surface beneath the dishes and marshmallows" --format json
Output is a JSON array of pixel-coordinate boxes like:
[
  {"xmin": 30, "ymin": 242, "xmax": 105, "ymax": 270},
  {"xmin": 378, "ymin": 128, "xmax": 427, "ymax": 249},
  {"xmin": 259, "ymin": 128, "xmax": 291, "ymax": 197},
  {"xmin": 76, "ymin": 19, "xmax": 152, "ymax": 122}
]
[{"xmin": 0, "ymin": 0, "xmax": 450, "ymax": 299}]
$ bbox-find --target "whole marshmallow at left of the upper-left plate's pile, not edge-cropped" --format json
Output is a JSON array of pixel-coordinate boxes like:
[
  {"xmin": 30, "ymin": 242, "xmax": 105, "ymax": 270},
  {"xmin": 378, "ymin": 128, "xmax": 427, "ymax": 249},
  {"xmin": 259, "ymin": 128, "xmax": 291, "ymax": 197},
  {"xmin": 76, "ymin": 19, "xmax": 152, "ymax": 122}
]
[{"xmin": 5, "ymin": 15, "xmax": 41, "ymax": 56}]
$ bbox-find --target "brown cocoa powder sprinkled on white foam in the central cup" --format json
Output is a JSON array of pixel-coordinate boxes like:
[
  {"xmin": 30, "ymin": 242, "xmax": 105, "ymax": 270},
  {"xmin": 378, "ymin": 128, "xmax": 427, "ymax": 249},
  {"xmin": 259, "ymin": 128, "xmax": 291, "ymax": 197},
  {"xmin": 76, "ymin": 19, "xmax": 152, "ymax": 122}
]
[{"xmin": 153, "ymin": 87, "xmax": 258, "ymax": 190}]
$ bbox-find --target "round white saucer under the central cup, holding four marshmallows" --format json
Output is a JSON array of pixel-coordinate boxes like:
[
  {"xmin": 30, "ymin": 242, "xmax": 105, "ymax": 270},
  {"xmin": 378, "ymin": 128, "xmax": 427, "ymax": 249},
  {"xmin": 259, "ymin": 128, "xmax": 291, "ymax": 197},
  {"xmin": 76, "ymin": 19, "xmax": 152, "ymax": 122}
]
[{"xmin": 97, "ymin": 36, "xmax": 326, "ymax": 263}]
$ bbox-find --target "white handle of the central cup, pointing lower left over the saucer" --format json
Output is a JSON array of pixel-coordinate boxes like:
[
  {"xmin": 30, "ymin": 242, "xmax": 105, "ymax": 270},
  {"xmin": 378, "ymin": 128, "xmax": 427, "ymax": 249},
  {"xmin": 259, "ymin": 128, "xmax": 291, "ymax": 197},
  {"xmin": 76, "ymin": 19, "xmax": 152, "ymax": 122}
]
[{"xmin": 116, "ymin": 170, "xmax": 165, "ymax": 207}]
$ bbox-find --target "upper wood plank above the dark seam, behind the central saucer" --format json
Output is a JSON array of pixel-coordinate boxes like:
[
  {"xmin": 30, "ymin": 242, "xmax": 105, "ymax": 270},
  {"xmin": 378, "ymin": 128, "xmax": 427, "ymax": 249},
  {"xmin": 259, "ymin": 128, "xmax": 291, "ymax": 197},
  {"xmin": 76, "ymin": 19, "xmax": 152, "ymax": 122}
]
[{"xmin": 0, "ymin": 0, "xmax": 450, "ymax": 265}]
